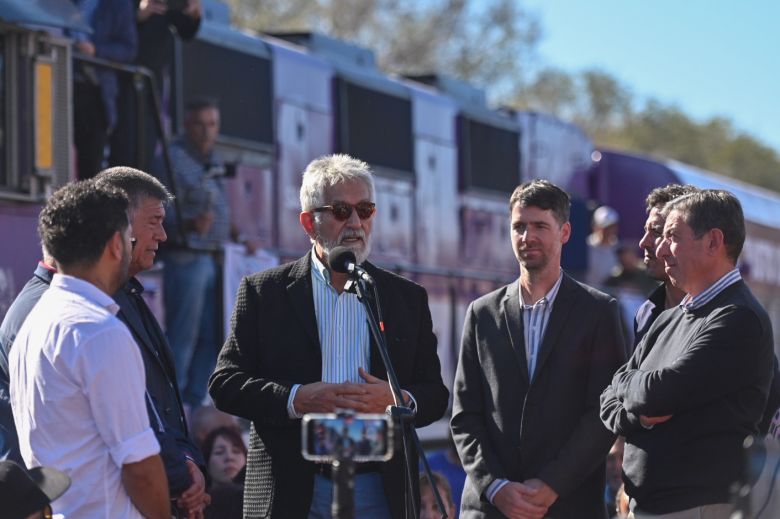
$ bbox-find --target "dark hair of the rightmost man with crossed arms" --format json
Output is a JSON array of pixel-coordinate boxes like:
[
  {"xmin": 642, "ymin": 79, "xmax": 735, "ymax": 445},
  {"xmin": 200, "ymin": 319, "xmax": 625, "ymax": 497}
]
[{"xmin": 661, "ymin": 189, "xmax": 745, "ymax": 264}]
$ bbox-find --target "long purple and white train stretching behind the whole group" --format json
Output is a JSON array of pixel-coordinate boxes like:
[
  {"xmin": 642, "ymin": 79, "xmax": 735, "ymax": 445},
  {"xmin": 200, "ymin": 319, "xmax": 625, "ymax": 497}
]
[{"xmin": 0, "ymin": 0, "xmax": 780, "ymax": 438}]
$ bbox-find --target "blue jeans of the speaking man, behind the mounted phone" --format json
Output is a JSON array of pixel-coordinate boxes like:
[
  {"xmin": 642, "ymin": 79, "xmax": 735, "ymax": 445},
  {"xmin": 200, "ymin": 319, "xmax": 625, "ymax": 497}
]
[{"xmin": 309, "ymin": 472, "xmax": 390, "ymax": 519}]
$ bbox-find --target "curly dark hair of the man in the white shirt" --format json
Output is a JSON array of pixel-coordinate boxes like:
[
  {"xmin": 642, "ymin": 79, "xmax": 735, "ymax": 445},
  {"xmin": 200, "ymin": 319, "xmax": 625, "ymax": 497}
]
[{"xmin": 38, "ymin": 180, "xmax": 129, "ymax": 267}]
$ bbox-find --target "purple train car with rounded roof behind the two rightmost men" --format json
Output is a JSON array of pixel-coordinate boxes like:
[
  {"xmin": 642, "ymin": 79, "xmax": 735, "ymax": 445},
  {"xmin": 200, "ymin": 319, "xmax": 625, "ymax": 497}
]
[{"xmin": 570, "ymin": 150, "xmax": 780, "ymax": 354}]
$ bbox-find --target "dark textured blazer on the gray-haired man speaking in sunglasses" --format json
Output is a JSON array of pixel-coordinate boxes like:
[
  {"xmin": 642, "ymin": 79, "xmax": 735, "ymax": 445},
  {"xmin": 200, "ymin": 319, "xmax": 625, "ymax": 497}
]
[{"xmin": 209, "ymin": 253, "xmax": 449, "ymax": 519}]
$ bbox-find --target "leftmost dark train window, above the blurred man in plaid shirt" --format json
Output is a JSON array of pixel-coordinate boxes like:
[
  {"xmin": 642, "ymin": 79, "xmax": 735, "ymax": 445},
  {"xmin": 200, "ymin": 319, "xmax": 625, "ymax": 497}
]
[{"xmin": 182, "ymin": 40, "xmax": 274, "ymax": 144}]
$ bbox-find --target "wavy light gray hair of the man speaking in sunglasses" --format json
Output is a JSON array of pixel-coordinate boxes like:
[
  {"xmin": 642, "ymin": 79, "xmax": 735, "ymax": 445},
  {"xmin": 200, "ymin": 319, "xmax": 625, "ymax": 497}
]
[{"xmin": 301, "ymin": 154, "xmax": 375, "ymax": 211}]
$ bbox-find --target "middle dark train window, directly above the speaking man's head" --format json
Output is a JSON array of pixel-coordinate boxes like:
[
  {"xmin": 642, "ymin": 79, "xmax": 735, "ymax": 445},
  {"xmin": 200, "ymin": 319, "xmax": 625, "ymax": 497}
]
[{"xmin": 338, "ymin": 81, "xmax": 414, "ymax": 174}]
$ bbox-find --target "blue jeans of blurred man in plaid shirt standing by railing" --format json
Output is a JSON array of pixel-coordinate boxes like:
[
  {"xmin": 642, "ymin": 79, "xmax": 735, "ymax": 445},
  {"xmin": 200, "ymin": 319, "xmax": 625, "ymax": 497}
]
[{"xmin": 163, "ymin": 251, "xmax": 220, "ymax": 408}]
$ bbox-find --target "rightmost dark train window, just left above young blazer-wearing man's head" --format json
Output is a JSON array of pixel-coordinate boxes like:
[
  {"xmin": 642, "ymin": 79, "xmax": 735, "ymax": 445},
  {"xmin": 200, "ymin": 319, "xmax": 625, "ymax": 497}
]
[{"xmin": 458, "ymin": 116, "xmax": 520, "ymax": 193}]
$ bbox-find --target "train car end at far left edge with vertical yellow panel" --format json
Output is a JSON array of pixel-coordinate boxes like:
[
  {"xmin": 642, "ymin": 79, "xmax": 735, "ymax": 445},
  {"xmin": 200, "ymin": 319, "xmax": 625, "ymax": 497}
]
[{"xmin": 0, "ymin": 0, "xmax": 80, "ymax": 318}]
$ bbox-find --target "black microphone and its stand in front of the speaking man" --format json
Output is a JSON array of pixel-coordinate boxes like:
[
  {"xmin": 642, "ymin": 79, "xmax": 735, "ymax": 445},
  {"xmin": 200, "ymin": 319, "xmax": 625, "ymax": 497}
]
[{"xmin": 344, "ymin": 280, "xmax": 447, "ymax": 519}]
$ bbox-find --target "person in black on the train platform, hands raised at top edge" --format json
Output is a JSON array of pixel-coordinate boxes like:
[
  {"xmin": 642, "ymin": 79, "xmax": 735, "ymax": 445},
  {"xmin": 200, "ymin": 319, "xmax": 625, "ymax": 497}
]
[{"xmin": 110, "ymin": 0, "xmax": 203, "ymax": 169}]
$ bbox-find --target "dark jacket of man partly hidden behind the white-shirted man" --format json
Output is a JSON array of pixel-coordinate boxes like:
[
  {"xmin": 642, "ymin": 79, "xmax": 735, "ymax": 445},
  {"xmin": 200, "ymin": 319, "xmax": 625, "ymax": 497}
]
[{"xmin": 114, "ymin": 278, "xmax": 206, "ymax": 486}]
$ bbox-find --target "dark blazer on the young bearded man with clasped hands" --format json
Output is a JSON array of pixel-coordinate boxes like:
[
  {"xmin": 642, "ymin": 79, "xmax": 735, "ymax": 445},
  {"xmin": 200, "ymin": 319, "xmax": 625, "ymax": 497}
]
[{"xmin": 451, "ymin": 274, "xmax": 625, "ymax": 519}]
